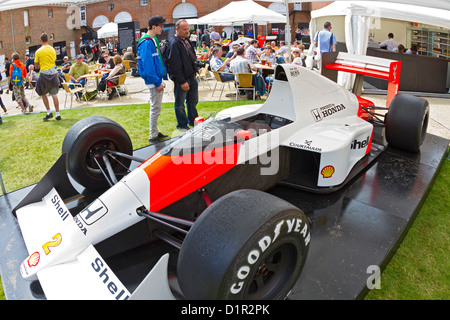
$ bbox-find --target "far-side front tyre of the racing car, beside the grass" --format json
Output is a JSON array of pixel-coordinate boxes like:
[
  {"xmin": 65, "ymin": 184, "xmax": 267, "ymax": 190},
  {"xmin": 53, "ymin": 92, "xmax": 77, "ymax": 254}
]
[{"xmin": 62, "ymin": 116, "xmax": 133, "ymax": 190}]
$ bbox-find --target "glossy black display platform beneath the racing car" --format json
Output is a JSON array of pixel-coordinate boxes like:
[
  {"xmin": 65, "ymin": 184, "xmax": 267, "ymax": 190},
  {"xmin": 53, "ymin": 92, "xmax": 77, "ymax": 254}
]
[{"xmin": 0, "ymin": 134, "xmax": 449, "ymax": 300}]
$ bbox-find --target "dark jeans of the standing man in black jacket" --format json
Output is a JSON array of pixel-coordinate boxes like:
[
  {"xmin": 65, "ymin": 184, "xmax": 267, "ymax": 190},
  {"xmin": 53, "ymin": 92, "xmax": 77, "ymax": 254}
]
[{"xmin": 174, "ymin": 78, "xmax": 198, "ymax": 129}]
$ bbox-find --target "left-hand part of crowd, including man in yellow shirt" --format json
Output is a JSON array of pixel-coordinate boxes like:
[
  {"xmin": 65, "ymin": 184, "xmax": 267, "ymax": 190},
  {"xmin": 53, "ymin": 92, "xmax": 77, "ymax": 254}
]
[{"xmin": 0, "ymin": 33, "xmax": 139, "ymax": 123}]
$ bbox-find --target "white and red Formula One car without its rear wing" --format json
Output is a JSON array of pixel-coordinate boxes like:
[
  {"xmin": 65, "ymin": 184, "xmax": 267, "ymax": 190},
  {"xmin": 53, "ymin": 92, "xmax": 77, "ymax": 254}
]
[{"xmin": 13, "ymin": 64, "xmax": 429, "ymax": 299}]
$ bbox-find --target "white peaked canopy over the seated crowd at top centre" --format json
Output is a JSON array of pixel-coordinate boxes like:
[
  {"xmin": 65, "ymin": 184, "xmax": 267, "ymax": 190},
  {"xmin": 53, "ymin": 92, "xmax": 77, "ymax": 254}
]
[{"xmin": 197, "ymin": 0, "xmax": 286, "ymax": 25}]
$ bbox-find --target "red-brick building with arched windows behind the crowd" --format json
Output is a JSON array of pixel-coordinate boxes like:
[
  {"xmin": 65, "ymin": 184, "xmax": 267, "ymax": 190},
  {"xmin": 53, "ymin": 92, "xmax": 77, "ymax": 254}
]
[{"xmin": 0, "ymin": 0, "xmax": 332, "ymax": 63}]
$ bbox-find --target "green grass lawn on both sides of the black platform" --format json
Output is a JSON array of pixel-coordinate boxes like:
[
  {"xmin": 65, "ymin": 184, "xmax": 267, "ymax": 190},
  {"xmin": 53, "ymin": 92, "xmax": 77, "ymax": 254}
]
[{"xmin": 0, "ymin": 101, "xmax": 450, "ymax": 300}]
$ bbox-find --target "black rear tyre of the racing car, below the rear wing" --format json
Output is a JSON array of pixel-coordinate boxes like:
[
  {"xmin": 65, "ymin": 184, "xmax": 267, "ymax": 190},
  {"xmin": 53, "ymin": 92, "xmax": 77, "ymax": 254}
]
[{"xmin": 385, "ymin": 94, "xmax": 430, "ymax": 152}]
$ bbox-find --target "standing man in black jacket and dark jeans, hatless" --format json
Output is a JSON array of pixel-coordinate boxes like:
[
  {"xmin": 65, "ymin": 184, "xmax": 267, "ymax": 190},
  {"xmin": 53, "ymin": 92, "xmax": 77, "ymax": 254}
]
[{"xmin": 164, "ymin": 19, "xmax": 198, "ymax": 131}]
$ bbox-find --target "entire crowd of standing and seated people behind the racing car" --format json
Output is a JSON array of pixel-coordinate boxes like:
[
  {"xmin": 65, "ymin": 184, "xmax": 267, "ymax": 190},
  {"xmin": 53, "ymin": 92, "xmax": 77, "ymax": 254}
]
[{"xmin": 0, "ymin": 16, "xmax": 310, "ymax": 130}]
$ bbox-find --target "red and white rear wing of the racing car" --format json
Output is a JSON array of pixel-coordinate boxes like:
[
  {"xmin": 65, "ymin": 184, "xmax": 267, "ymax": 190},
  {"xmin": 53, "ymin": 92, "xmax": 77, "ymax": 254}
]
[{"xmin": 322, "ymin": 52, "xmax": 401, "ymax": 107}]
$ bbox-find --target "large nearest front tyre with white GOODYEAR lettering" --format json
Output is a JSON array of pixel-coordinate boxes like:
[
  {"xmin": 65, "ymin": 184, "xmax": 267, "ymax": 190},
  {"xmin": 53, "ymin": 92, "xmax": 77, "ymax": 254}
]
[{"xmin": 177, "ymin": 190, "xmax": 310, "ymax": 300}]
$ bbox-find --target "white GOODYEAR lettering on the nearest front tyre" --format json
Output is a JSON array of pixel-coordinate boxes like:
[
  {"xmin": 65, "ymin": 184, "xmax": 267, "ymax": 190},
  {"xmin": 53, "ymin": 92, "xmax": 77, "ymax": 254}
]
[{"xmin": 230, "ymin": 218, "xmax": 311, "ymax": 294}]
